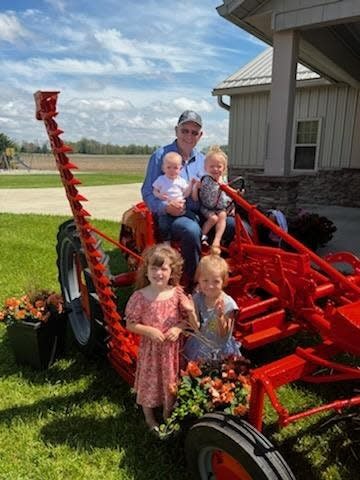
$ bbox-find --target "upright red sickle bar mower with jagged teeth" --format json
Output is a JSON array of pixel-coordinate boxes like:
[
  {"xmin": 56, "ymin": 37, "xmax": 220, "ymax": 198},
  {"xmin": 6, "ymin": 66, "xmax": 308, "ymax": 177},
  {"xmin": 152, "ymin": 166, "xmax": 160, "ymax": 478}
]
[{"xmin": 34, "ymin": 92, "xmax": 139, "ymax": 383}]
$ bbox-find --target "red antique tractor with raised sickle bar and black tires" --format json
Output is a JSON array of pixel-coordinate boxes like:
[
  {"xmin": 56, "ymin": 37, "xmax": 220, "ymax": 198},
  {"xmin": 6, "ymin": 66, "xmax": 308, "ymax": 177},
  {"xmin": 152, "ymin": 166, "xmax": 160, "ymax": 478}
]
[{"xmin": 35, "ymin": 92, "xmax": 360, "ymax": 480}]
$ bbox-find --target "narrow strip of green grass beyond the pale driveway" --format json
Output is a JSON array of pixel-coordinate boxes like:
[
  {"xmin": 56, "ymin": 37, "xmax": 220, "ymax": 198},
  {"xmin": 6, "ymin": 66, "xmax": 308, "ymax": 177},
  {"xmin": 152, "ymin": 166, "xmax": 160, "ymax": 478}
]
[{"xmin": 0, "ymin": 172, "xmax": 144, "ymax": 188}]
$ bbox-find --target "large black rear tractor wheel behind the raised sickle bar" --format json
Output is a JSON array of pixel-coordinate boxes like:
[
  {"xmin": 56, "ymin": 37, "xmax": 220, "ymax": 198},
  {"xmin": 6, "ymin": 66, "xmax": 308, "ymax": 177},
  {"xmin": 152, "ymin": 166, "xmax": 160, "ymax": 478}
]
[{"xmin": 56, "ymin": 220, "xmax": 106, "ymax": 355}]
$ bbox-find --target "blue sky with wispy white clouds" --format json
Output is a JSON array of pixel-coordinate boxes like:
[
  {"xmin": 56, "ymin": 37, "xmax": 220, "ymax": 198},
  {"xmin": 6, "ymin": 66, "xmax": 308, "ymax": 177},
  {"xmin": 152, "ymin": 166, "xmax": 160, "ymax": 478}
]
[{"xmin": 0, "ymin": 0, "xmax": 266, "ymax": 146}]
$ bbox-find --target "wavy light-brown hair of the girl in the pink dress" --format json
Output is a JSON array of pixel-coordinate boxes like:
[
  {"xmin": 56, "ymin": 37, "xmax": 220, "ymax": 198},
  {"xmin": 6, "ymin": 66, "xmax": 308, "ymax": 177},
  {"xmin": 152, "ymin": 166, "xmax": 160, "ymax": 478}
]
[{"xmin": 135, "ymin": 243, "xmax": 184, "ymax": 289}]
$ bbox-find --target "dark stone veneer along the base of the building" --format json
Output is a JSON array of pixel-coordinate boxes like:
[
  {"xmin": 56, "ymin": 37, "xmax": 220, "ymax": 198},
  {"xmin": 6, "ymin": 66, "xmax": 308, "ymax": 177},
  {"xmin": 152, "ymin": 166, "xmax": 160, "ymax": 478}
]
[{"xmin": 229, "ymin": 168, "xmax": 360, "ymax": 210}]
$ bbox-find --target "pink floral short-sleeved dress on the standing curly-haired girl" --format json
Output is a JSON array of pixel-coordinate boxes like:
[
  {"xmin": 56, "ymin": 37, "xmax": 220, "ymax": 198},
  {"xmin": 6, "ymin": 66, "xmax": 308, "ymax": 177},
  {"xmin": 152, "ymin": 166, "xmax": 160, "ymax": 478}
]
[{"xmin": 125, "ymin": 287, "xmax": 185, "ymax": 409}]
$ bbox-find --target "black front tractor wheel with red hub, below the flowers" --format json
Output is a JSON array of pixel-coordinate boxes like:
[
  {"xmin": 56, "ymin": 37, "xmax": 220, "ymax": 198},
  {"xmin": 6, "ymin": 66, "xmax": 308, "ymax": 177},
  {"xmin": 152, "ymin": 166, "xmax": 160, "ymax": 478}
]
[{"xmin": 185, "ymin": 413, "xmax": 295, "ymax": 480}]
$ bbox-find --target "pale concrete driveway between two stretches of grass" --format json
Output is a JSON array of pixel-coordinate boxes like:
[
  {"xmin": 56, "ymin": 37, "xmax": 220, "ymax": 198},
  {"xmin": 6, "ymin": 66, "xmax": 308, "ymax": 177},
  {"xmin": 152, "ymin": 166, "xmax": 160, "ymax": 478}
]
[{"xmin": 0, "ymin": 183, "xmax": 141, "ymax": 221}]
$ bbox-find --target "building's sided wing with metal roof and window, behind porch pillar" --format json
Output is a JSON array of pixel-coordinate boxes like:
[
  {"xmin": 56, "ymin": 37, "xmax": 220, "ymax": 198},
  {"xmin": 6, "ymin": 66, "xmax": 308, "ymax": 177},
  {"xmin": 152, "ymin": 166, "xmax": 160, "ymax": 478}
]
[{"xmin": 213, "ymin": 47, "xmax": 360, "ymax": 206}]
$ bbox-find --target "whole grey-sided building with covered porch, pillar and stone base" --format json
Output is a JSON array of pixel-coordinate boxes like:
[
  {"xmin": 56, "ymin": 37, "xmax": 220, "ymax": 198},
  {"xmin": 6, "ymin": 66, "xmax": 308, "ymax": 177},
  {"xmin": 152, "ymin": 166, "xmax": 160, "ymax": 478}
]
[{"xmin": 213, "ymin": 0, "xmax": 360, "ymax": 209}]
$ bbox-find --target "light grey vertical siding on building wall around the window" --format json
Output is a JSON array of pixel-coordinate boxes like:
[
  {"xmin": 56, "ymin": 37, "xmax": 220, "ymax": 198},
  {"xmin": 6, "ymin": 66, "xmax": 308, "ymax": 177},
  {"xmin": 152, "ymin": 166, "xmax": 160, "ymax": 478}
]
[{"xmin": 229, "ymin": 86, "xmax": 358, "ymax": 170}]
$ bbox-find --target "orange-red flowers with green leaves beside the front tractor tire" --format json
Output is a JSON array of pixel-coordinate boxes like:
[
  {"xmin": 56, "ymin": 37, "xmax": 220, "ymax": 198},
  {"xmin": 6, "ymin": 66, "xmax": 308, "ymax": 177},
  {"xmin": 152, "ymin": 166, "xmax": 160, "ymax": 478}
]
[{"xmin": 160, "ymin": 356, "xmax": 250, "ymax": 436}]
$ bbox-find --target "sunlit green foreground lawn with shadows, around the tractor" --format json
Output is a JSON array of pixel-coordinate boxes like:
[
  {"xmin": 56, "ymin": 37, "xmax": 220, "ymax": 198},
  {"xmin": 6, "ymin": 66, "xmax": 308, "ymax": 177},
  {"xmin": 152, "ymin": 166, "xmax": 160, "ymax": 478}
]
[{"xmin": 0, "ymin": 214, "xmax": 360, "ymax": 480}]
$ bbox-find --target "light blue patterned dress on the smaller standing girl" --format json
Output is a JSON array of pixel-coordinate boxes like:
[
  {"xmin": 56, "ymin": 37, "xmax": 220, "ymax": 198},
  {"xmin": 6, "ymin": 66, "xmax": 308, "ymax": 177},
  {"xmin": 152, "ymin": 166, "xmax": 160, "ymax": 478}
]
[{"xmin": 183, "ymin": 293, "xmax": 241, "ymax": 360}]
